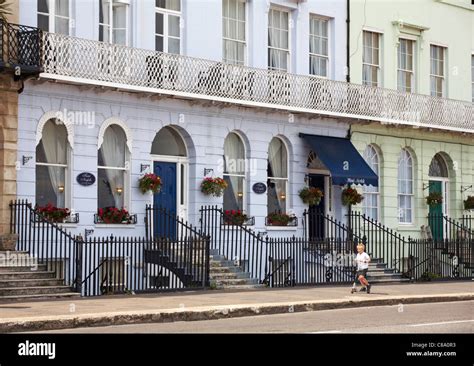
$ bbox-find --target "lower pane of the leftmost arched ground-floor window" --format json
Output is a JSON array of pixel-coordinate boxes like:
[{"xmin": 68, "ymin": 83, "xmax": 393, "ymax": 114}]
[{"xmin": 36, "ymin": 165, "xmax": 66, "ymax": 208}]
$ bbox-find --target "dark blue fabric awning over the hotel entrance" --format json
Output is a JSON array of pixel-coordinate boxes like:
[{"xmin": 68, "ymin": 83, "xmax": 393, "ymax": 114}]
[{"xmin": 300, "ymin": 133, "xmax": 379, "ymax": 187}]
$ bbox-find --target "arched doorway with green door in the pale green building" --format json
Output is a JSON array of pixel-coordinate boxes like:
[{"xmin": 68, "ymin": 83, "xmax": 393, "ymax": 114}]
[{"xmin": 428, "ymin": 153, "xmax": 449, "ymax": 240}]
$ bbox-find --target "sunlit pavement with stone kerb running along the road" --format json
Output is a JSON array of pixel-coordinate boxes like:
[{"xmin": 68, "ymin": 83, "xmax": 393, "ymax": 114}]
[{"xmin": 0, "ymin": 281, "xmax": 474, "ymax": 333}]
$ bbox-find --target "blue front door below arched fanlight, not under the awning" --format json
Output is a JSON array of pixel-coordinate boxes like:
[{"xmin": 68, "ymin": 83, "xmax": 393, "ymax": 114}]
[{"xmin": 153, "ymin": 161, "xmax": 177, "ymax": 238}]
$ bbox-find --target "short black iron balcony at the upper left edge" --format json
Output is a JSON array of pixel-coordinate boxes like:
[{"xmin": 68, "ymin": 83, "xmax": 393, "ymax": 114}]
[{"xmin": 0, "ymin": 20, "xmax": 43, "ymax": 79}]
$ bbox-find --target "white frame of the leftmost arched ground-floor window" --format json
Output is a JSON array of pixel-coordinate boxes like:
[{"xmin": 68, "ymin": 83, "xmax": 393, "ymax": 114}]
[{"xmin": 35, "ymin": 120, "xmax": 74, "ymax": 213}]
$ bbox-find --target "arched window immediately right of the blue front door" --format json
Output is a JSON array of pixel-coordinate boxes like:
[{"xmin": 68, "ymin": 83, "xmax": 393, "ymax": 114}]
[{"xmin": 224, "ymin": 132, "xmax": 245, "ymax": 210}]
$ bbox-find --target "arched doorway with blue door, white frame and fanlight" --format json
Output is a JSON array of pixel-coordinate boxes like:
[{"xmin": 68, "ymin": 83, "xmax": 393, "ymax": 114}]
[{"xmin": 150, "ymin": 126, "xmax": 189, "ymax": 236}]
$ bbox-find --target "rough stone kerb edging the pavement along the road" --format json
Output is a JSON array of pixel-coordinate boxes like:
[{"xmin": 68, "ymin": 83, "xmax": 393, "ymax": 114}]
[{"xmin": 0, "ymin": 293, "xmax": 474, "ymax": 333}]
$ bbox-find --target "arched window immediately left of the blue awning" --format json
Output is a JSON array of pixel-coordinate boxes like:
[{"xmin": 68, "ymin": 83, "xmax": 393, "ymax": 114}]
[{"xmin": 267, "ymin": 137, "xmax": 288, "ymax": 214}]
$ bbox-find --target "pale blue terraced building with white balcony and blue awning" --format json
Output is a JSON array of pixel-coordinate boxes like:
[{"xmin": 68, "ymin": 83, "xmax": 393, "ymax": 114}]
[{"xmin": 0, "ymin": 0, "xmax": 474, "ymax": 298}]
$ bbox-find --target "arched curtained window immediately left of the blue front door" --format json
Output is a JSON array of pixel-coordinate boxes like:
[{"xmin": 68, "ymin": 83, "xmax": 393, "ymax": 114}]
[{"xmin": 97, "ymin": 124, "xmax": 129, "ymax": 209}]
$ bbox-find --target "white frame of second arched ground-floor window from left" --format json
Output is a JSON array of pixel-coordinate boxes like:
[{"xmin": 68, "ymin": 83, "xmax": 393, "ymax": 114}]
[{"xmin": 97, "ymin": 123, "xmax": 132, "ymax": 211}]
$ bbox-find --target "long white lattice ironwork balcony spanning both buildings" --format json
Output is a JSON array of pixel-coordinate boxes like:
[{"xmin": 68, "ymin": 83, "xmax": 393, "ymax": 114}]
[{"xmin": 41, "ymin": 33, "xmax": 474, "ymax": 133}]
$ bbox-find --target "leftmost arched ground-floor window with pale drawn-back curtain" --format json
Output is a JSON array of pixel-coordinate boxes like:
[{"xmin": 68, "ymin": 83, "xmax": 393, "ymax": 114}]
[{"xmin": 36, "ymin": 119, "xmax": 70, "ymax": 208}]
